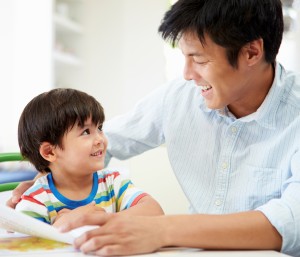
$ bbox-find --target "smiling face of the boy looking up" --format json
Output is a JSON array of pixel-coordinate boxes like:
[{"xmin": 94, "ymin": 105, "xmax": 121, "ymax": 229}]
[{"xmin": 52, "ymin": 118, "xmax": 107, "ymax": 176}]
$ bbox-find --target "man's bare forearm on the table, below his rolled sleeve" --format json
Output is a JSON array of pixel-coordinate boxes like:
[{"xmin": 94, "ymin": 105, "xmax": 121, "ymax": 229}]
[{"xmin": 161, "ymin": 211, "xmax": 282, "ymax": 251}]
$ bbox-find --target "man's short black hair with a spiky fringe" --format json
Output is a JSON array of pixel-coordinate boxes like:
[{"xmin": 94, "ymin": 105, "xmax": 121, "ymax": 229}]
[{"xmin": 158, "ymin": 0, "xmax": 283, "ymax": 67}]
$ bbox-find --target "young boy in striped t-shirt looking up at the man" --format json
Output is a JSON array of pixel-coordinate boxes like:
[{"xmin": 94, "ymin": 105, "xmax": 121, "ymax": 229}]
[{"xmin": 16, "ymin": 89, "xmax": 163, "ymax": 224}]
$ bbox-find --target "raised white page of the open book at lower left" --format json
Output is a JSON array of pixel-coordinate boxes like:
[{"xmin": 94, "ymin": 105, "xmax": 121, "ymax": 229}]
[{"xmin": 0, "ymin": 205, "xmax": 99, "ymax": 252}]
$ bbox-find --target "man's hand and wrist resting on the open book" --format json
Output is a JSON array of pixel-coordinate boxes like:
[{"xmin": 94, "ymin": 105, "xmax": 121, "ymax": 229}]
[{"xmin": 60, "ymin": 212, "xmax": 165, "ymax": 256}]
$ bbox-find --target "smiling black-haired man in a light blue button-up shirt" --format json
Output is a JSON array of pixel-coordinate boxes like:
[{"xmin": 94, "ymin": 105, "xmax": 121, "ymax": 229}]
[{"xmin": 8, "ymin": 0, "xmax": 300, "ymax": 256}]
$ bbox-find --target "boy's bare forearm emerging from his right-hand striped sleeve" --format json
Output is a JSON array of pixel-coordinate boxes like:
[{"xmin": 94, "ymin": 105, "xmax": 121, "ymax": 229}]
[{"xmin": 119, "ymin": 195, "xmax": 164, "ymax": 216}]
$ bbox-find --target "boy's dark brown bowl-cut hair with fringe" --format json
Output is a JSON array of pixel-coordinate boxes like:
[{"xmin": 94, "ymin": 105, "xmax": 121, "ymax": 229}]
[{"xmin": 18, "ymin": 88, "xmax": 105, "ymax": 172}]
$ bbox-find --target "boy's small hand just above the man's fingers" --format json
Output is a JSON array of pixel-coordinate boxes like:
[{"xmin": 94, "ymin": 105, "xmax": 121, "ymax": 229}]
[{"xmin": 53, "ymin": 202, "xmax": 106, "ymax": 227}]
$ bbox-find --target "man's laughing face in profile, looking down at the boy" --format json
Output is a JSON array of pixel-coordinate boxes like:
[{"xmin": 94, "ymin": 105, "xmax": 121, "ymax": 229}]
[{"xmin": 179, "ymin": 33, "xmax": 264, "ymax": 116}]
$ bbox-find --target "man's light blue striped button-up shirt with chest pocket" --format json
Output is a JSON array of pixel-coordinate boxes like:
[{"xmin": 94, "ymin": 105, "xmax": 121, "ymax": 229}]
[{"xmin": 104, "ymin": 64, "xmax": 300, "ymax": 256}]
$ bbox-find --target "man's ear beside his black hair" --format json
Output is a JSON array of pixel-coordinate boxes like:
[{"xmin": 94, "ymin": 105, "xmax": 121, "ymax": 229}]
[{"xmin": 242, "ymin": 38, "xmax": 264, "ymax": 66}]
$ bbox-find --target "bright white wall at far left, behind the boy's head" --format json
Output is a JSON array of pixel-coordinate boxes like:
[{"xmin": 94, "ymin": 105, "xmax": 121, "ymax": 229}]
[{"xmin": 0, "ymin": 0, "xmax": 52, "ymax": 151}]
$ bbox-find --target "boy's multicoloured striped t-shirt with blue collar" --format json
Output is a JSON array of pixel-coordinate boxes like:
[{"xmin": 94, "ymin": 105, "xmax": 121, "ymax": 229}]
[{"xmin": 16, "ymin": 170, "xmax": 147, "ymax": 224}]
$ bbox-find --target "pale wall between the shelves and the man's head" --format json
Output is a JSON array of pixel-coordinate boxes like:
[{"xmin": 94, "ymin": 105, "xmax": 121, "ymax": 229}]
[{"xmin": 82, "ymin": 0, "xmax": 168, "ymax": 118}]
